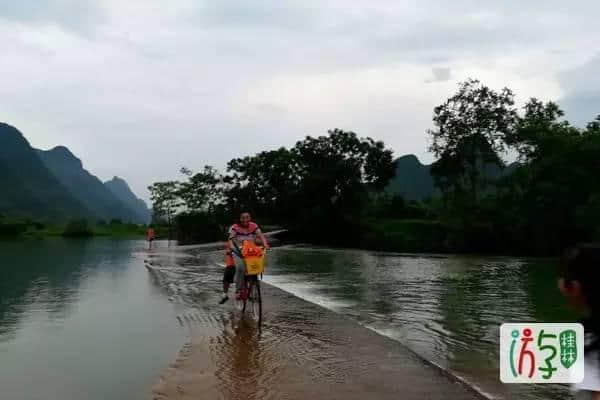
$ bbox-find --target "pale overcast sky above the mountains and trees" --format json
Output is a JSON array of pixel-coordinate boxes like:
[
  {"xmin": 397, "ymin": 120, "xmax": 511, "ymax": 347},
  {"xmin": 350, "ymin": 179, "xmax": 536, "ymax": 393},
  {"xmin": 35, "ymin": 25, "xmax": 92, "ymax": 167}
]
[{"xmin": 0, "ymin": 0, "xmax": 600, "ymax": 203}]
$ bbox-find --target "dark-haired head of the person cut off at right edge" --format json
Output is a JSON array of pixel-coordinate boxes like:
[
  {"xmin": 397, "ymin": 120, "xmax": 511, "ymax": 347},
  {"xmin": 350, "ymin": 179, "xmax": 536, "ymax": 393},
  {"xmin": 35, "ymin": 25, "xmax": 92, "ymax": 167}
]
[{"xmin": 558, "ymin": 244, "xmax": 600, "ymax": 317}]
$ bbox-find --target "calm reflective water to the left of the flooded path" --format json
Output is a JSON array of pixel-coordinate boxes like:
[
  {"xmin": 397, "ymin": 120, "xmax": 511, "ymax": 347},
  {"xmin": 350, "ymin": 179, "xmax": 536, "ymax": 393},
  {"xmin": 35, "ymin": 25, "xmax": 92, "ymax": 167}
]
[{"xmin": 0, "ymin": 239, "xmax": 185, "ymax": 400}]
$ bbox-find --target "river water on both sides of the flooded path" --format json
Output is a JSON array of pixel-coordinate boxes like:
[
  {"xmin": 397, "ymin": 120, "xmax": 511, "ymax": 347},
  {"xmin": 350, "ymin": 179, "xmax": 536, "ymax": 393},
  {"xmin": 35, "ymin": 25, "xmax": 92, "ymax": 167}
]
[{"xmin": 0, "ymin": 239, "xmax": 574, "ymax": 400}]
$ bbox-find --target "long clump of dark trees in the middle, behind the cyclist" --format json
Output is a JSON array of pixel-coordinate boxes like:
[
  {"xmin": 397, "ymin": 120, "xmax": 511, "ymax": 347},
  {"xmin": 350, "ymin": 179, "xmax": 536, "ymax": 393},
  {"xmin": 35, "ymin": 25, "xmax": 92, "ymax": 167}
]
[{"xmin": 149, "ymin": 130, "xmax": 394, "ymax": 245}]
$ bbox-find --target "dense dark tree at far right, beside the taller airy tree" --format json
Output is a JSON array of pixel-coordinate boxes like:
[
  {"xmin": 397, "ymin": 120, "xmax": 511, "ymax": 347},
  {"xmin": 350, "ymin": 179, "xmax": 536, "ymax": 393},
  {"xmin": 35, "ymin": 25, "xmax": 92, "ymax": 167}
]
[{"xmin": 490, "ymin": 99, "xmax": 600, "ymax": 254}]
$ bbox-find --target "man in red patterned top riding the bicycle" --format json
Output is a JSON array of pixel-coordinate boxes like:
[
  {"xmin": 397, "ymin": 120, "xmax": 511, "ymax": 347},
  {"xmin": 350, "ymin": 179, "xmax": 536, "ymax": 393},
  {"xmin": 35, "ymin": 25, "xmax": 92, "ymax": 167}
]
[{"xmin": 219, "ymin": 212, "xmax": 269, "ymax": 304}]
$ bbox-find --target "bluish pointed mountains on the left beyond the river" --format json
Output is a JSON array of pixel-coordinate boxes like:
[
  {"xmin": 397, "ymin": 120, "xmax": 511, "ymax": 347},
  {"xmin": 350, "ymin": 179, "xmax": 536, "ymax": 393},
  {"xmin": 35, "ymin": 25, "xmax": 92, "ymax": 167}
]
[{"xmin": 0, "ymin": 123, "xmax": 150, "ymax": 223}]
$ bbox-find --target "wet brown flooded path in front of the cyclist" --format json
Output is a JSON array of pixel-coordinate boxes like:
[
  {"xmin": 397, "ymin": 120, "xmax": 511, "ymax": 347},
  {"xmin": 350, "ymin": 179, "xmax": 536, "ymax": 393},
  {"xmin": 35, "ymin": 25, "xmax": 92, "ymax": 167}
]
[{"xmin": 152, "ymin": 285, "xmax": 478, "ymax": 400}]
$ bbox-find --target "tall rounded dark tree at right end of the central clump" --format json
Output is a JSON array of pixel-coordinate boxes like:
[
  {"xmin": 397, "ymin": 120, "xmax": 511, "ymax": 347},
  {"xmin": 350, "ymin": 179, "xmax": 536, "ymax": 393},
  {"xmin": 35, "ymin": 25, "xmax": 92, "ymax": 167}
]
[{"xmin": 292, "ymin": 129, "xmax": 395, "ymax": 245}]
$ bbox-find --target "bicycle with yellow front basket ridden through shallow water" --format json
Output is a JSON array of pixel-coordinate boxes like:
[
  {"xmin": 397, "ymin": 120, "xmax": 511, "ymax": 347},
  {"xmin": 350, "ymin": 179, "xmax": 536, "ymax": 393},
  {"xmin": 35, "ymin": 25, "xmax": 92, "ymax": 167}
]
[{"xmin": 235, "ymin": 241, "xmax": 266, "ymax": 322}]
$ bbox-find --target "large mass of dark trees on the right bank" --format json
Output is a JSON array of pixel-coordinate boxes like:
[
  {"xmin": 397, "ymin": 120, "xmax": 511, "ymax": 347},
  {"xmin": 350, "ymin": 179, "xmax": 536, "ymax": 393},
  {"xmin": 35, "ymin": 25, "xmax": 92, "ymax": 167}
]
[{"xmin": 431, "ymin": 81, "xmax": 600, "ymax": 255}]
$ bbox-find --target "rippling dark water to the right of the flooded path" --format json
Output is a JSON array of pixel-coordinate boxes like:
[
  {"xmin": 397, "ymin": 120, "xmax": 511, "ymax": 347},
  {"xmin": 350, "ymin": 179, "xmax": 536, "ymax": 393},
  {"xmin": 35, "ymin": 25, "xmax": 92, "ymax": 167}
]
[{"xmin": 258, "ymin": 249, "xmax": 575, "ymax": 399}]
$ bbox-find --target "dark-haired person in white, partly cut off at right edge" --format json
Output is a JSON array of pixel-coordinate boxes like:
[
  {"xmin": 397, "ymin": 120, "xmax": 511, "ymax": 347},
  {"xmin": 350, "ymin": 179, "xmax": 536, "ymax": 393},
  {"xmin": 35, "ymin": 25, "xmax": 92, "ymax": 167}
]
[{"xmin": 558, "ymin": 244, "xmax": 600, "ymax": 400}]
